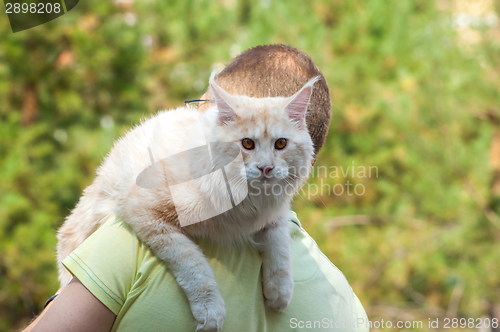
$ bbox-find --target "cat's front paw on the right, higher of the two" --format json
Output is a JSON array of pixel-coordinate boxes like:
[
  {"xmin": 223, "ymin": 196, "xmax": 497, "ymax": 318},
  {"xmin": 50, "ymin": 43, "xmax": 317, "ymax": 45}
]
[{"xmin": 262, "ymin": 270, "xmax": 293, "ymax": 311}]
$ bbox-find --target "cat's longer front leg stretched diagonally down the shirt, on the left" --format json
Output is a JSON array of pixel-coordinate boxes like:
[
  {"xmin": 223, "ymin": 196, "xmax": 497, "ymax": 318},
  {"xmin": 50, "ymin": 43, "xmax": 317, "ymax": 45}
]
[{"xmin": 132, "ymin": 220, "xmax": 226, "ymax": 331}]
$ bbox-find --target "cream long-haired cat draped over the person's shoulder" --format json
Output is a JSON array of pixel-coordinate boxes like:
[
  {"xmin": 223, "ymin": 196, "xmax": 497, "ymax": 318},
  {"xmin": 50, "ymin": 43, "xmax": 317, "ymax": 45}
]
[{"xmin": 57, "ymin": 73, "xmax": 320, "ymax": 331}]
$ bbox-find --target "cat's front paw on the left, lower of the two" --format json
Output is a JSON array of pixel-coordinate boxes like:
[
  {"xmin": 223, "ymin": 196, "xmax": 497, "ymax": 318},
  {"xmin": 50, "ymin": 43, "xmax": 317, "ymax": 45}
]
[{"xmin": 191, "ymin": 291, "xmax": 226, "ymax": 331}]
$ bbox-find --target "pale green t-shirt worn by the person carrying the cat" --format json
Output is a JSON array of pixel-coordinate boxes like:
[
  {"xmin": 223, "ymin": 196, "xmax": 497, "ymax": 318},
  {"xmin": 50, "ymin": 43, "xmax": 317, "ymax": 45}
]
[{"xmin": 63, "ymin": 212, "xmax": 368, "ymax": 332}]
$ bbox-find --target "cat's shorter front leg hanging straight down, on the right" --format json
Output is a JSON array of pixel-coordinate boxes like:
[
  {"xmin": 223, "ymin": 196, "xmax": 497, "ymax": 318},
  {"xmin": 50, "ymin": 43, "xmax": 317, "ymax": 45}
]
[{"xmin": 255, "ymin": 218, "xmax": 293, "ymax": 311}]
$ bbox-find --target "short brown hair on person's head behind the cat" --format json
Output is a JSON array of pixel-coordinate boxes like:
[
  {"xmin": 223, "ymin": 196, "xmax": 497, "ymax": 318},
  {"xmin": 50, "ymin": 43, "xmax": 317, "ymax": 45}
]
[{"xmin": 199, "ymin": 44, "xmax": 331, "ymax": 156}]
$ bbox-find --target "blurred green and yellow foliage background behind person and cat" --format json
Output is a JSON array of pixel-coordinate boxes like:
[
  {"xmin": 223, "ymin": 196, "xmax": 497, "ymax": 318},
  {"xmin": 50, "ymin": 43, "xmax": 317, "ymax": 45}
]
[{"xmin": 0, "ymin": 0, "xmax": 500, "ymax": 331}]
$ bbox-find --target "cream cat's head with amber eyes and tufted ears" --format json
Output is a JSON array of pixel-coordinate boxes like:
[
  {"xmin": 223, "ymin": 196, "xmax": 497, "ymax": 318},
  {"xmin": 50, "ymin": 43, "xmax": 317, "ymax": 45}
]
[{"xmin": 207, "ymin": 73, "xmax": 320, "ymax": 197}]
